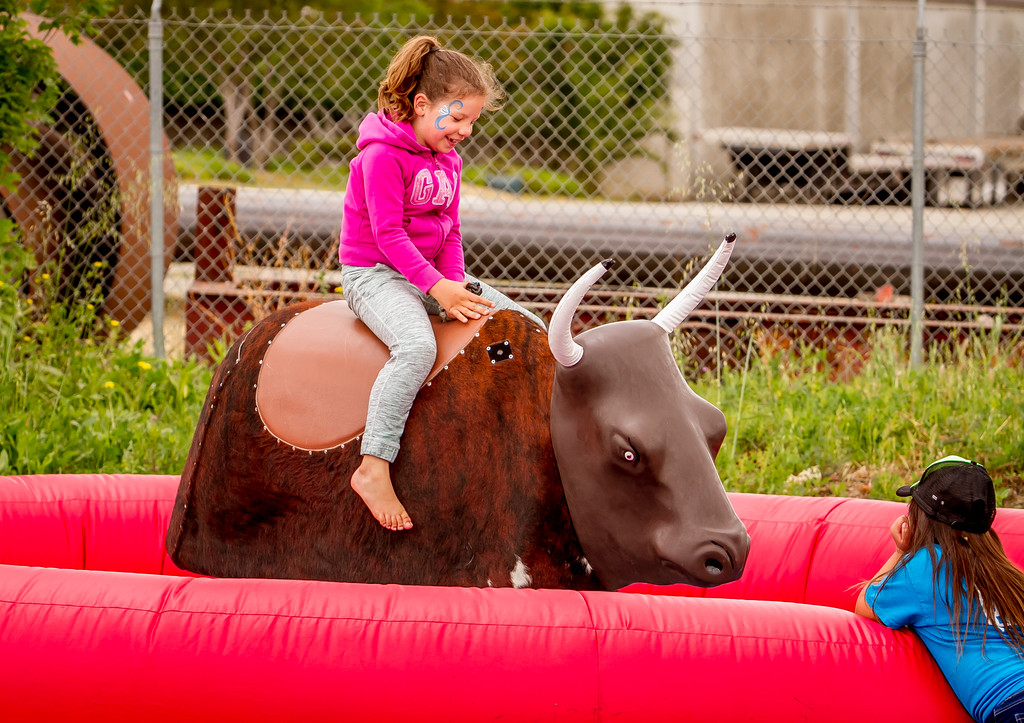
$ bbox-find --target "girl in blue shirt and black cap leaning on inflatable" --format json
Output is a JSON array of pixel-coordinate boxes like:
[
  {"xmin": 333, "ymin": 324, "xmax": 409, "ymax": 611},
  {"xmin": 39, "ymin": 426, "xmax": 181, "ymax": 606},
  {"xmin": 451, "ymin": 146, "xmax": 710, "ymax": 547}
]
[{"xmin": 856, "ymin": 456, "xmax": 1024, "ymax": 723}]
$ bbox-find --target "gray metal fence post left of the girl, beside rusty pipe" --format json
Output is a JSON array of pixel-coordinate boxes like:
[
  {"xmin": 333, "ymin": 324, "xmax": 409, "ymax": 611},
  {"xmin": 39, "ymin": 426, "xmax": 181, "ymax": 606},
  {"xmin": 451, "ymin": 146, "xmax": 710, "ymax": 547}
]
[{"xmin": 150, "ymin": 0, "xmax": 164, "ymax": 358}]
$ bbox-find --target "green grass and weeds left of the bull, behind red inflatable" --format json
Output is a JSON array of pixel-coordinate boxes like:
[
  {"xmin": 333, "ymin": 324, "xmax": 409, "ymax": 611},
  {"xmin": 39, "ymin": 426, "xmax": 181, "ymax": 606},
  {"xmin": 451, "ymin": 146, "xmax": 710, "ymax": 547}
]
[{"xmin": 0, "ymin": 237, "xmax": 211, "ymax": 474}]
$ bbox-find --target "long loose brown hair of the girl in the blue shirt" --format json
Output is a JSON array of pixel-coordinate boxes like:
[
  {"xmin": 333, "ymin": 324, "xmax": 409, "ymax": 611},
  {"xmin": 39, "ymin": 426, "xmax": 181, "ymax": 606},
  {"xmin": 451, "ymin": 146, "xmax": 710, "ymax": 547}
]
[{"xmin": 873, "ymin": 500, "xmax": 1024, "ymax": 656}]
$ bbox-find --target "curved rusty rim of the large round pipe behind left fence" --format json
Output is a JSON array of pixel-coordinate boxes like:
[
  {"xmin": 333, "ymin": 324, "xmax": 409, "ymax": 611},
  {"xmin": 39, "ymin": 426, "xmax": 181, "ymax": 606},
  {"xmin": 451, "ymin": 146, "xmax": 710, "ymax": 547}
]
[{"xmin": 4, "ymin": 13, "xmax": 177, "ymax": 329}]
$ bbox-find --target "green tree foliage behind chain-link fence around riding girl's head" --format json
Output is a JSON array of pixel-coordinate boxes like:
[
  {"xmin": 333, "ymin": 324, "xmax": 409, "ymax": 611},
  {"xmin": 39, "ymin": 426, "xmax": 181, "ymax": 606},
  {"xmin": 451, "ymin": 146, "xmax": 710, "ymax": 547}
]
[{"xmin": 102, "ymin": 0, "xmax": 673, "ymax": 186}]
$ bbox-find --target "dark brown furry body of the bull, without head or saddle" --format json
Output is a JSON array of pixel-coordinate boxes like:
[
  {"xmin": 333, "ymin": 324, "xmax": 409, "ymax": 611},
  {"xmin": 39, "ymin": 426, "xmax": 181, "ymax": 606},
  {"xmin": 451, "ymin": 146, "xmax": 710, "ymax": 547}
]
[{"xmin": 168, "ymin": 304, "xmax": 597, "ymax": 588}]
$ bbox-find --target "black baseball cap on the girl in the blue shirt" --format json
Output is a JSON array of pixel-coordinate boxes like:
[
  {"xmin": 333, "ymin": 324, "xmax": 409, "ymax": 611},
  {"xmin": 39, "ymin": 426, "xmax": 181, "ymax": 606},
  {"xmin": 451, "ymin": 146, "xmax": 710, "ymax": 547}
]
[{"xmin": 896, "ymin": 455, "xmax": 995, "ymax": 534}]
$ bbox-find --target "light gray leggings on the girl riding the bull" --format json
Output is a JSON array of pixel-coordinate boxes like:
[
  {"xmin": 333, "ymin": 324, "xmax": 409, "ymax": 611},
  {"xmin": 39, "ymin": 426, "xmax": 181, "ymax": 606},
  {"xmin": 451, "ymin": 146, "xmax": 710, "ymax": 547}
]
[{"xmin": 341, "ymin": 263, "xmax": 544, "ymax": 462}]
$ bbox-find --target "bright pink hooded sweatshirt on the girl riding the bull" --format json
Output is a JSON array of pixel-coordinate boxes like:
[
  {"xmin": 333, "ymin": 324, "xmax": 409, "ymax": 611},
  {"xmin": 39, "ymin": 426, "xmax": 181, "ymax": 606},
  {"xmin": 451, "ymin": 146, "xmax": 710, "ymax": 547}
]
[{"xmin": 338, "ymin": 112, "xmax": 466, "ymax": 293}]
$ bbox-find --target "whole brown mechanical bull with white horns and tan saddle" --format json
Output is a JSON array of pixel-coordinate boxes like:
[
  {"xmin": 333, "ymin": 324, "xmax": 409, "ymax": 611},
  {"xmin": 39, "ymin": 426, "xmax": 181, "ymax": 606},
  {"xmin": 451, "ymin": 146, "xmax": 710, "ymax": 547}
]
[{"xmin": 167, "ymin": 236, "xmax": 750, "ymax": 589}]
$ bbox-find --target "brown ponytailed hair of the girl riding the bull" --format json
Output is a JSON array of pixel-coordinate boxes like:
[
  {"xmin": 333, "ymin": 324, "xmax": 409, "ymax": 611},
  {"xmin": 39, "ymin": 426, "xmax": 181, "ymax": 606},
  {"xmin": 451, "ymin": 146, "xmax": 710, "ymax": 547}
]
[{"xmin": 377, "ymin": 35, "xmax": 505, "ymax": 123}]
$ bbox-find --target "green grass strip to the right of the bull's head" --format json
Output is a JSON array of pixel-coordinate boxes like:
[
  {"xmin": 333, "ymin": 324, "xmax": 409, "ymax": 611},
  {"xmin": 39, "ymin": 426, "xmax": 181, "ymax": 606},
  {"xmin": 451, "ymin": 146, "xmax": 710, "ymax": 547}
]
[{"xmin": 693, "ymin": 330, "xmax": 1024, "ymax": 502}]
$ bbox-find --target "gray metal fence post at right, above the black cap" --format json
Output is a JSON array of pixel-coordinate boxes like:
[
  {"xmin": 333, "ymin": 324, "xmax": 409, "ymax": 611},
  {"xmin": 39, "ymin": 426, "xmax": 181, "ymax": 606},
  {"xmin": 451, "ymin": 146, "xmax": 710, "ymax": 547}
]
[{"xmin": 910, "ymin": 0, "xmax": 928, "ymax": 369}]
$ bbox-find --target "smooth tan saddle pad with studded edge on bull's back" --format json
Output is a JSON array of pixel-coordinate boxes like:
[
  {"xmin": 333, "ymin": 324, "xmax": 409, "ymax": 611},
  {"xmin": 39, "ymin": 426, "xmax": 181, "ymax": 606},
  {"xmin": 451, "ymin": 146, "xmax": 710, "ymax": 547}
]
[{"xmin": 250, "ymin": 301, "xmax": 487, "ymax": 450}]
